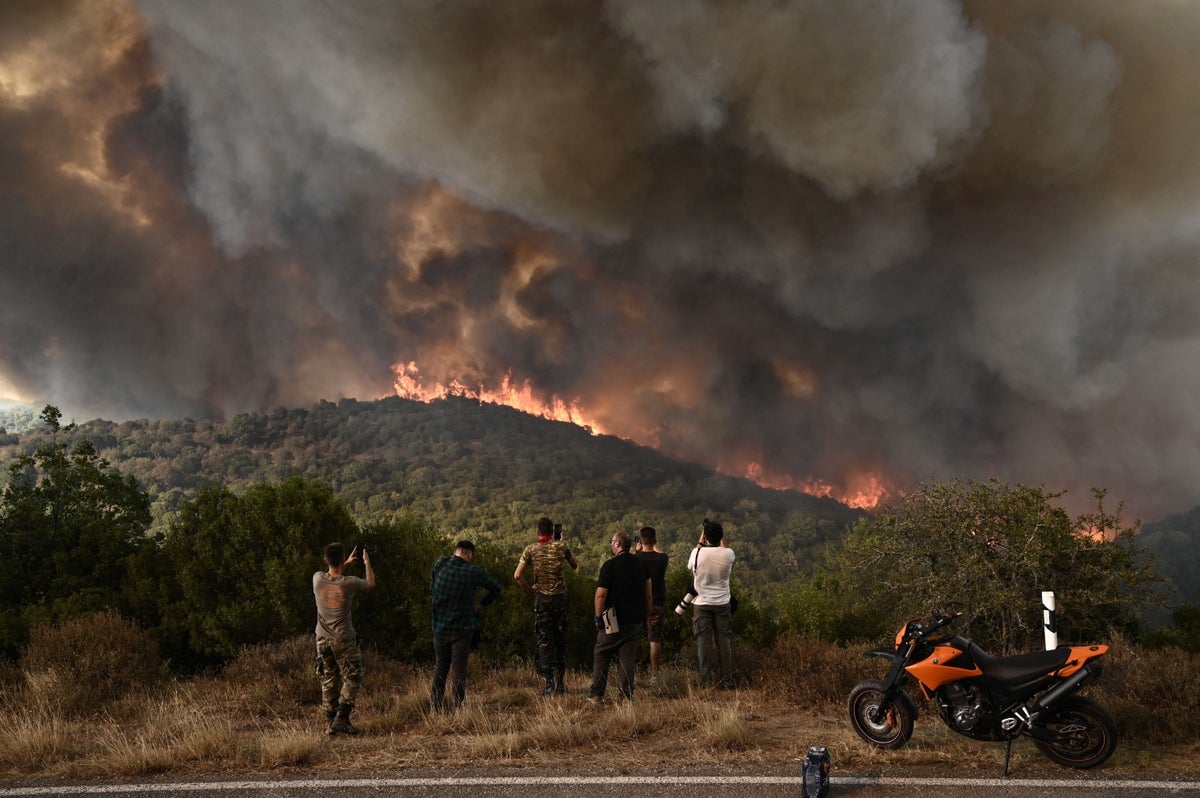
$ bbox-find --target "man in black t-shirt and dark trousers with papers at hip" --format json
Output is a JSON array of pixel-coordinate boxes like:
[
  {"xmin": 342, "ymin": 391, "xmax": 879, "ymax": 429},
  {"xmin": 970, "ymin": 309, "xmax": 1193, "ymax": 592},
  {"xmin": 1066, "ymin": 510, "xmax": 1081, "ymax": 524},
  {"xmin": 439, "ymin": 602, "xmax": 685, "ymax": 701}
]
[{"xmin": 588, "ymin": 532, "xmax": 652, "ymax": 703}]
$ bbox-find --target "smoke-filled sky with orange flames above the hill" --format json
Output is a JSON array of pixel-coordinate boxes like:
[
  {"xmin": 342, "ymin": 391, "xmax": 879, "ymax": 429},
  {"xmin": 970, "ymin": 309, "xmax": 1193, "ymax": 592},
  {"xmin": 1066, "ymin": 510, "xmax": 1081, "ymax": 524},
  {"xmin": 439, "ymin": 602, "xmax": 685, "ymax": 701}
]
[{"xmin": 0, "ymin": 0, "xmax": 1200, "ymax": 520}]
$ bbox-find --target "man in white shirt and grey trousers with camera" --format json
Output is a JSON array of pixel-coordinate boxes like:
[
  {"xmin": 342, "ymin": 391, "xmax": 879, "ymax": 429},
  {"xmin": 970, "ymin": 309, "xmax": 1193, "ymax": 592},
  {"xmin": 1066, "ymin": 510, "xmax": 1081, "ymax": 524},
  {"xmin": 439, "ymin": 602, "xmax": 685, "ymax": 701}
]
[{"xmin": 688, "ymin": 518, "xmax": 733, "ymax": 690}]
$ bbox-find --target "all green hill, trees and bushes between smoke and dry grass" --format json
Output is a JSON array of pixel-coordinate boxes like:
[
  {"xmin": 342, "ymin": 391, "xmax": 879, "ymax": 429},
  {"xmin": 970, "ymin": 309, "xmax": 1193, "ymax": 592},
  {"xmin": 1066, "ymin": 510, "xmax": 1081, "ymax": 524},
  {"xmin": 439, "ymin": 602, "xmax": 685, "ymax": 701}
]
[{"xmin": 0, "ymin": 398, "xmax": 1193, "ymax": 671}]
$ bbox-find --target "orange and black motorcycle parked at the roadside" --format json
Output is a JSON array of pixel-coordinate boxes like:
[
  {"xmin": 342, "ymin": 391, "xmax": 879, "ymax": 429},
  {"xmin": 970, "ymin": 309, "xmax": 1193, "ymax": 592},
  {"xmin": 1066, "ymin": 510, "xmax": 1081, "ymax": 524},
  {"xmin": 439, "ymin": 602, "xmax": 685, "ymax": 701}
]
[{"xmin": 850, "ymin": 613, "xmax": 1117, "ymax": 775}]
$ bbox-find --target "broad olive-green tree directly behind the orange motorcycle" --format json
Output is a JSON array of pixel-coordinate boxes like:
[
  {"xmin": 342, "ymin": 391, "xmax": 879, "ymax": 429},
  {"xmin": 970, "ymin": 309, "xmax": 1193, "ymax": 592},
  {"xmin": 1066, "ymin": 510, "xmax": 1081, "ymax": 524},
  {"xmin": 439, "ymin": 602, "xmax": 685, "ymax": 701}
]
[{"xmin": 785, "ymin": 479, "xmax": 1159, "ymax": 653}]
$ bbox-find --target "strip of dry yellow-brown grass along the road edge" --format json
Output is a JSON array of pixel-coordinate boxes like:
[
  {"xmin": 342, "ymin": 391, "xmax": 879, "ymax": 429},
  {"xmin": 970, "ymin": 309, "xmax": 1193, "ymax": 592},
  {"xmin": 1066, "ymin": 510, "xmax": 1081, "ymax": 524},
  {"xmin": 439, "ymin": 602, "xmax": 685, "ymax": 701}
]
[{"xmin": 0, "ymin": 638, "xmax": 1200, "ymax": 779}]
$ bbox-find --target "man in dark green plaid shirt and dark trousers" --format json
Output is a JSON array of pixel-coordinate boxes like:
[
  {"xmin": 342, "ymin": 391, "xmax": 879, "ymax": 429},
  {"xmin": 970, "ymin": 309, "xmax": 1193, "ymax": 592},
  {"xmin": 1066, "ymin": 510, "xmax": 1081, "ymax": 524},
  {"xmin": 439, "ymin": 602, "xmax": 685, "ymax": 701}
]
[{"xmin": 430, "ymin": 540, "xmax": 500, "ymax": 712}]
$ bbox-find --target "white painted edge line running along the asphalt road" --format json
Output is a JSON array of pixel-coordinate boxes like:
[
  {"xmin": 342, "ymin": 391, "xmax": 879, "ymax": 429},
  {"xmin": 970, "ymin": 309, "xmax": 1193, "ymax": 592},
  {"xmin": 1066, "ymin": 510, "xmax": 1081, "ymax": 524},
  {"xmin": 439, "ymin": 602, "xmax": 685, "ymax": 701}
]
[{"xmin": 0, "ymin": 775, "xmax": 1200, "ymax": 797}]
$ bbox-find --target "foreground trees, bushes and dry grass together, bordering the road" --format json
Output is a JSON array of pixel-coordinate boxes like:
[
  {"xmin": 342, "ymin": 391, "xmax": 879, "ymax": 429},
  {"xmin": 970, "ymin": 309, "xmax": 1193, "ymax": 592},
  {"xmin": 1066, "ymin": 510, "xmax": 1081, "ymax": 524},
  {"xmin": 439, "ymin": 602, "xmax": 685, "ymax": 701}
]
[{"xmin": 7, "ymin": 407, "xmax": 1200, "ymax": 779}]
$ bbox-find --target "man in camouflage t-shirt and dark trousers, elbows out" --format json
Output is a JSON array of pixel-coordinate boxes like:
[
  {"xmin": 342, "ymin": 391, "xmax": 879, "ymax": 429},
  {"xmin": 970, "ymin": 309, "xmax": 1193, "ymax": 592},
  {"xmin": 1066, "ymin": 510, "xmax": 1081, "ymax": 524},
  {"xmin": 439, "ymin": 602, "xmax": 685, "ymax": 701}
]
[{"xmin": 512, "ymin": 518, "xmax": 580, "ymax": 696}]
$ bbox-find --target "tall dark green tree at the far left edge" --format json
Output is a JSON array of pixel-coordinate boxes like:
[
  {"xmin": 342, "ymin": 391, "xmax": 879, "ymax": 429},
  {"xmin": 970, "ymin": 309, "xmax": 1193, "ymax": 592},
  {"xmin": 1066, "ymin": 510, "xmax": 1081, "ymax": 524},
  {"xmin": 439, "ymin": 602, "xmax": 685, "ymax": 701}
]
[{"xmin": 0, "ymin": 404, "xmax": 150, "ymax": 655}]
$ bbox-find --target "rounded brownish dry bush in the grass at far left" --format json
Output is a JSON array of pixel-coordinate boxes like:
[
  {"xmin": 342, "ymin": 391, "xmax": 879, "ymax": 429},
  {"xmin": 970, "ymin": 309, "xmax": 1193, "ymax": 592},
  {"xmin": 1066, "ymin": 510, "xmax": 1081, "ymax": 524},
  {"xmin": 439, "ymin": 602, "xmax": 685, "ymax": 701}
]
[{"xmin": 20, "ymin": 610, "xmax": 164, "ymax": 716}]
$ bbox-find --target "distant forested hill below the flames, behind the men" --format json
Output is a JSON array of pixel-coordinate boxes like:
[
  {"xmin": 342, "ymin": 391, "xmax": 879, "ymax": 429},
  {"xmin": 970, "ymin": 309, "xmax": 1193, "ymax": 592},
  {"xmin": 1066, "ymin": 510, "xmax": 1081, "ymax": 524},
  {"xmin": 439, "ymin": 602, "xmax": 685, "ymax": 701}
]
[{"xmin": 0, "ymin": 397, "xmax": 862, "ymax": 587}]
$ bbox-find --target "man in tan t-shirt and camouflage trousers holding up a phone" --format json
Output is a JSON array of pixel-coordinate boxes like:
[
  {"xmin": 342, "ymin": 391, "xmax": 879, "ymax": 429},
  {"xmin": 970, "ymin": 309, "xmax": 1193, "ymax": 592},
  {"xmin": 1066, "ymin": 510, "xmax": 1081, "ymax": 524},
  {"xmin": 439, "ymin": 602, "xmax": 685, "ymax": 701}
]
[{"xmin": 312, "ymin": 544, "xmax": 374, "ymax": 734}]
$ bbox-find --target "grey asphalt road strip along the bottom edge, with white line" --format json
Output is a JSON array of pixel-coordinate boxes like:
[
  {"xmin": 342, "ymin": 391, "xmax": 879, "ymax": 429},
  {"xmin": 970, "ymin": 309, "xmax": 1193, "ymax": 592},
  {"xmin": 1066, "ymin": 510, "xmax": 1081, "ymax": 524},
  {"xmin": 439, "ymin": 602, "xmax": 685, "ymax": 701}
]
[{"xmin": 7, "ymin": 772, "xmax": 1200, "ymax": 798}]
